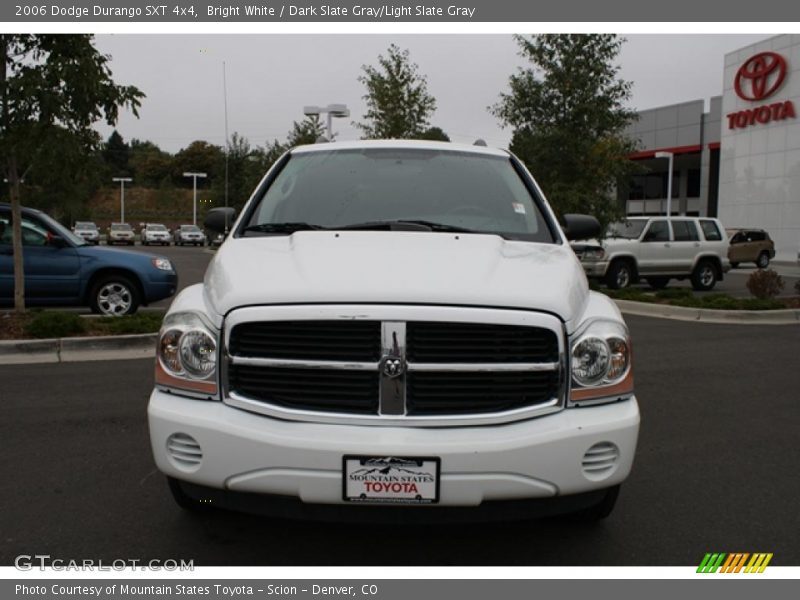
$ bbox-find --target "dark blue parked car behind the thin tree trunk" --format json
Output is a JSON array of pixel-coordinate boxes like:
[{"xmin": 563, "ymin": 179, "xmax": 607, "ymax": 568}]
[{"xmin": 0, "ymin": 203, "xmax": 178, "ymax": 316}]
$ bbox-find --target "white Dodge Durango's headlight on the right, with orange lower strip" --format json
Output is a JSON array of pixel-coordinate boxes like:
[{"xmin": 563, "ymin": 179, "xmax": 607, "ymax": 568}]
[{"xmin": 570, "ymin": 321, "xmax": 633, "ymax": 403}]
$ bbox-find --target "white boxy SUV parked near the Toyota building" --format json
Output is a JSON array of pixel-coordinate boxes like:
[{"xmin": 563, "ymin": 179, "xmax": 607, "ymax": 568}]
[{"xmin": 572, "ymin": 217, "xmax": 730, "ymax": 291}]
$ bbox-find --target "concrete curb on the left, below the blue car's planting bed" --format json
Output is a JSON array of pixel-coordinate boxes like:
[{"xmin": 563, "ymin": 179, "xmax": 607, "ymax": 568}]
[{"xmin": 0, "ymin": 333, "xmax": 158, "ymax": 365}]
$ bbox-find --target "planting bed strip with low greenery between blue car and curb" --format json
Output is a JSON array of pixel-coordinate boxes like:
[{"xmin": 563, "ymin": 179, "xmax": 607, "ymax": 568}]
[{"xmin": 0, "ymin": 310, "xmax": 164, "ymax": 340}]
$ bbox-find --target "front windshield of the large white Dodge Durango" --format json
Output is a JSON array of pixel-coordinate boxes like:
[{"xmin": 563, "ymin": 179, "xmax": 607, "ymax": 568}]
[{"xmin": 245, "ymin": 148, "xmax": 554, "ymax": 242}]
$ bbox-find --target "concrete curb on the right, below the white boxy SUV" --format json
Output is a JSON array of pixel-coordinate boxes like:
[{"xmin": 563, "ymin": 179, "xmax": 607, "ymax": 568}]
[{"xmin": 614, "ymin": 300, "xmax": 800, "ymax": 325}]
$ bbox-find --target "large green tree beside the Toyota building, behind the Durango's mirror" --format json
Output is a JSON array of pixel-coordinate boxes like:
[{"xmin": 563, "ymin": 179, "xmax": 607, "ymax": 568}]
[{"xmin": 490, "ymin": 34, "xmax": 636, "ymax": 231}]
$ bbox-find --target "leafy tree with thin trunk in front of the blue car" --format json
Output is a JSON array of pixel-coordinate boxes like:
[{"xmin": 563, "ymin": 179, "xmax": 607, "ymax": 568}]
[{"xmin": 0, "ymin": 34, "xmax": 144, "ymax": 312}]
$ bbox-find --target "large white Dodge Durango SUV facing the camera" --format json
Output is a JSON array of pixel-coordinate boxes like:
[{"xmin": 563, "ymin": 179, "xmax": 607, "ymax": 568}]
[{"xmin": 148, "ymin": 141, "xmax": 639, "ymax": 519}]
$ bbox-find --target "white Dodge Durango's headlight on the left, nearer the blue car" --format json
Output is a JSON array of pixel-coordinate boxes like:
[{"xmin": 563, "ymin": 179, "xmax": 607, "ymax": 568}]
[{"xmin": 156, "ymin": 313, "xmax": 219, "ymax": 397}]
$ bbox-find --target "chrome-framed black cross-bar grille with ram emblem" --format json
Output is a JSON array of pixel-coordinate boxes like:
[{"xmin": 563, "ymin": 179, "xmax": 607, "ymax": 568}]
[{"xmin": 223, "ymin": 307, "xmax": 564, "ymax": 426}]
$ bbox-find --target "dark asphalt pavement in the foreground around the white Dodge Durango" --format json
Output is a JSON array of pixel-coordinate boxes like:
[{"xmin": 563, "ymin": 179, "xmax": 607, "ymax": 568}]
[{"xmin": 0, "ymin": 314, "xmax": 800, "ymax": 566}]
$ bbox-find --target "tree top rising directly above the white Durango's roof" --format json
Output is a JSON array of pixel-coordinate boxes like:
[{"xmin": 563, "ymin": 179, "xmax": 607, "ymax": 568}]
[{"xmin": 355, "ymin": 44, "xmax": 436, "ymax": 139}]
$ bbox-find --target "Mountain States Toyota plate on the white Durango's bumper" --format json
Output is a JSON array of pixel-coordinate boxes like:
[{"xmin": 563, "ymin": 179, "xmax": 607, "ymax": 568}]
[{"xmin": 342, "ymin": 456, "xmax": 440, "ymax": 504}]
